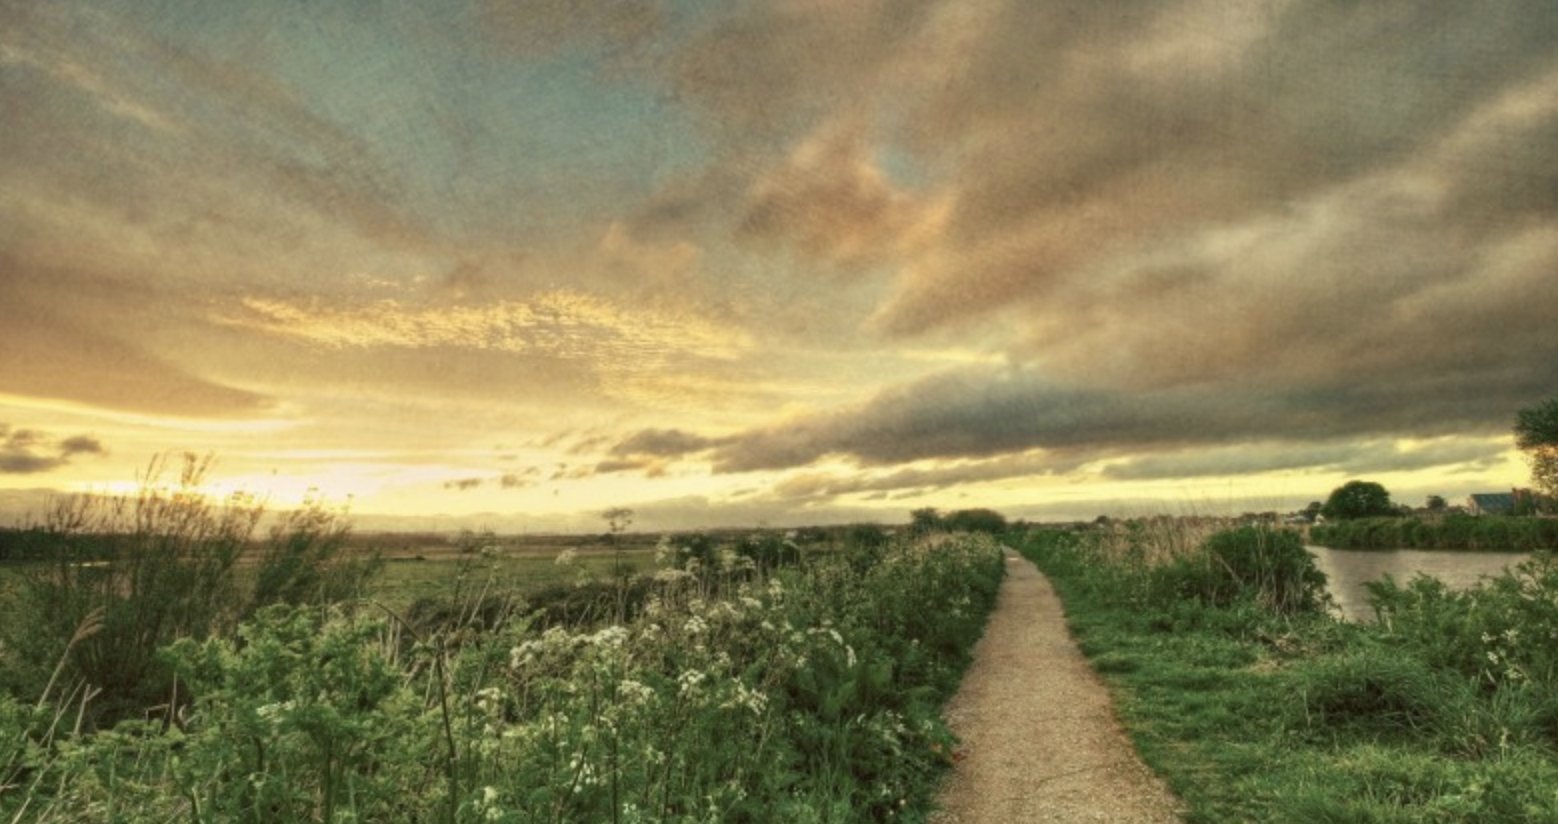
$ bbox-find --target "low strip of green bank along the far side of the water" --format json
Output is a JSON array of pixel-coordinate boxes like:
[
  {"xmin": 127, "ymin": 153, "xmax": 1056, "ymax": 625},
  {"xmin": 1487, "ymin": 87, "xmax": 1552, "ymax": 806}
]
[{"xmin": 1309, "ymin": 514, "xmax": 1558, "ymax": 551}]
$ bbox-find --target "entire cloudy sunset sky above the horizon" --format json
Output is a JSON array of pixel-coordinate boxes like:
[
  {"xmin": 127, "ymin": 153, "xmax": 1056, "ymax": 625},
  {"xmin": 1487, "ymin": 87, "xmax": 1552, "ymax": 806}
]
[{"xmin": 0, "ymin": 0, "xmax": 1558, "ymax": 531}]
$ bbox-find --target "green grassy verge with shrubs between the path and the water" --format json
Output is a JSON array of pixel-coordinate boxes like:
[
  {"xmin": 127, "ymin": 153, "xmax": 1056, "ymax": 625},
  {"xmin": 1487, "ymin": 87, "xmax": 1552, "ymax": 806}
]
[{"xmin": 1024, "ymin": 530, "xmax": 1558, "ymax": 822}]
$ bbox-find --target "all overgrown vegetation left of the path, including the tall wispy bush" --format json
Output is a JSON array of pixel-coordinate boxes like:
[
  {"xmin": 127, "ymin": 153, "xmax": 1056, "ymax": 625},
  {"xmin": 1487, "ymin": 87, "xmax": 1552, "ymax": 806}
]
[{"xmin": 0, "ymin": 470, "xmax": 1003, "ymax": 822}]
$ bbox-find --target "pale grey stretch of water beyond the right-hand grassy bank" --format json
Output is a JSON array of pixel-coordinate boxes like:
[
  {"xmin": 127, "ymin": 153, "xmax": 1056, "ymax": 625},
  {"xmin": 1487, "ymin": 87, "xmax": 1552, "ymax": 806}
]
[{"xmin": 1307, "ymin": 547, "xmax": 1530, "ymax": 622}]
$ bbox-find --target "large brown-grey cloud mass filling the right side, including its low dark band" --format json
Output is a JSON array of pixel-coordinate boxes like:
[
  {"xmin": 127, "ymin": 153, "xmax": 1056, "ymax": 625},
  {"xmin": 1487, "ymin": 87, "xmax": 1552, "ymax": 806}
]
[{"xmin": 645, "ymin": 0, "xmax": 1558, "ymax": 488}]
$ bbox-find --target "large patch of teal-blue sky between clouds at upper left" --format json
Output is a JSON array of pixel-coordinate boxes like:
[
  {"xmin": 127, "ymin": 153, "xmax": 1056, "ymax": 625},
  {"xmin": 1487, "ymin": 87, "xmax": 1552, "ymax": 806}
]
[{"xmin": 129, "ymin": 3, "xmax": 707, "ymax": 240}]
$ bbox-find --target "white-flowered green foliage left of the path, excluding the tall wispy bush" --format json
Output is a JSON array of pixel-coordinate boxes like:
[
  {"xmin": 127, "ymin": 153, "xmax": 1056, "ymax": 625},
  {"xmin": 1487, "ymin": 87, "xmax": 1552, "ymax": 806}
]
[{"xmin": 0, "ymin": 537, "xmax": 1005, "ymax": 822}]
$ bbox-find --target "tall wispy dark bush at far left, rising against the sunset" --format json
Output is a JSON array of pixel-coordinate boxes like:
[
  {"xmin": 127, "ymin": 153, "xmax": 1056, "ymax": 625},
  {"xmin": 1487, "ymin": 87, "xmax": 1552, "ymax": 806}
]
[{"xmin": 0, "ymin": 455, "xmax": 372, "ymax": 723}]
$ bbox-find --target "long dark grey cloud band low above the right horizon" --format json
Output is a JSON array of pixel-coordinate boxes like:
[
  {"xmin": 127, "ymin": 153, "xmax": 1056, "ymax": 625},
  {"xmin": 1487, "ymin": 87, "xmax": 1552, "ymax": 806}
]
[{"xmin": 712, "ymin": 361, "xmax": 1558, "ymax": 472}]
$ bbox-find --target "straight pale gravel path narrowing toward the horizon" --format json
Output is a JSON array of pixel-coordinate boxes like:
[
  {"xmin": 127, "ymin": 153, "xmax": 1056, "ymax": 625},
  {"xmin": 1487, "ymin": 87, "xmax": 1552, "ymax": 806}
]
[{"xmin": 930, "ymin": 550, "xmax": 1179, "ymax": 824}]
